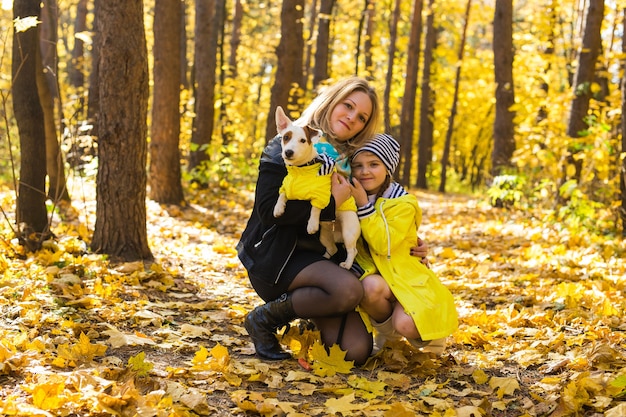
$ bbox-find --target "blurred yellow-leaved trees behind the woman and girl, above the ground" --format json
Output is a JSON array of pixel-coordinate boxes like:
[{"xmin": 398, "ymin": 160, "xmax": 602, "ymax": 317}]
[{"xmin": 0, "ymin": 0, "xmax": 626, "ymax": 257}]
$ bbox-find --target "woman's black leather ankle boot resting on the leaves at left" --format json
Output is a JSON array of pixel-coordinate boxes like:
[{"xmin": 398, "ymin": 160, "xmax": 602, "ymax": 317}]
[{"xmin": 244, "ymin": 294, "xmax": 296, "ymax": 361}]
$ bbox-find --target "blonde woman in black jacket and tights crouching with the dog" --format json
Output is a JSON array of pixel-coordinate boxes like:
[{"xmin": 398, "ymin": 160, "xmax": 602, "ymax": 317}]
[{"xmin": 237, "ymin": 77, "xmax": 379, "ymax": 364}]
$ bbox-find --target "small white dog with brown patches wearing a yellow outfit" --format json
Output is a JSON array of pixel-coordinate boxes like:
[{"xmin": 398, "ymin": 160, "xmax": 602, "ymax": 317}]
[{"xmin": 274, "ymin": 106, "xmax": 361, "ymax": 269}]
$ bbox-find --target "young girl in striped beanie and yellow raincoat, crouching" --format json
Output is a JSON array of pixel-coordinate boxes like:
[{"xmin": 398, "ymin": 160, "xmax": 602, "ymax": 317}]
[{"xmin": 351, "ymin": 134, "xmax": 458, "ymax": 354}]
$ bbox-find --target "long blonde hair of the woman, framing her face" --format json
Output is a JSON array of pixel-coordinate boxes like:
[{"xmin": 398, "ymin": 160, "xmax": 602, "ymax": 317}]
[{"xmin": 297, "ymin": 77, "xmax": 380, "ymax": 156}]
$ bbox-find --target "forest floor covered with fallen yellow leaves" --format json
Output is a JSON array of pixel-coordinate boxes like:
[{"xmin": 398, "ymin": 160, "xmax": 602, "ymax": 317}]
[{"xmin": 0, "ymin": 184, "xmax": 626, "ymax": 417}]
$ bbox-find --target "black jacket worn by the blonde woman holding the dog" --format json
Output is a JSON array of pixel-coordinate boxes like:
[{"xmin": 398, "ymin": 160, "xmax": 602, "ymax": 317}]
[{"xmin": 237, "ymin": 136, "xmax": 335, "ymax": 284}]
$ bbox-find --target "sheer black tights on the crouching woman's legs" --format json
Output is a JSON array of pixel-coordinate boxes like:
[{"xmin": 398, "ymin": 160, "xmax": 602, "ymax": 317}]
[{"xmin": 289, "ymin": 261, "xmax": 372, "ymax": 365}]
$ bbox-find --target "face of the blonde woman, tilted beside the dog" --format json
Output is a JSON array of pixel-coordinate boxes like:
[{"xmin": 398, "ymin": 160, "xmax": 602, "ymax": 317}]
[{"xmin": 330, "ymin": 91, "xmax": 372, "ymax": 142}]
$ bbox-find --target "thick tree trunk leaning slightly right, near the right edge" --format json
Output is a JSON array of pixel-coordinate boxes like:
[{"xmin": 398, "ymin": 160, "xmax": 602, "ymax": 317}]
[{"xmin": 557, "ymin": 0, "xmax": 604, "ymax": 186}]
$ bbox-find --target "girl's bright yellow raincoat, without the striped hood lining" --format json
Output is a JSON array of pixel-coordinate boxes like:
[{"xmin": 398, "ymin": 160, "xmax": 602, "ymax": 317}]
[{"xmin": 356, "ymin": 194, "xmax": 458, "ymax": 340}]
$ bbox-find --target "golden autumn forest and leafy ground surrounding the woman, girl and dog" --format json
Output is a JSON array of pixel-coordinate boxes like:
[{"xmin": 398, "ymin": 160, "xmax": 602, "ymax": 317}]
[{"xmin": 0, "ymin": 0, "xmax": 626, "ymax": 416}]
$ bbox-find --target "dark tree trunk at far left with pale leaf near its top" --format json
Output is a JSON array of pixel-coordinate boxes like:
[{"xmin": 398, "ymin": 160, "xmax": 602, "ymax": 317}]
[{"xmin": 11, "ymin": 0, "xmax": 49, "ymax": 251}]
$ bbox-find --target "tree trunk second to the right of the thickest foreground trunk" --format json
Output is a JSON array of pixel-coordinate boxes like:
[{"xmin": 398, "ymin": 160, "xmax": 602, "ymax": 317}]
[{"xmin": 188, "ymin": 0, "xmax": 218, "ymax": 172}]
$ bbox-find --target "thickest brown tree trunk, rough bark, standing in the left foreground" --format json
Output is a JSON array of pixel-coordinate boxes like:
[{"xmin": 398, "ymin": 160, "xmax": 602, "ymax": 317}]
[{"xmin": 91, "ymin": 0, "xmax": 152, "ymax": 261}]
